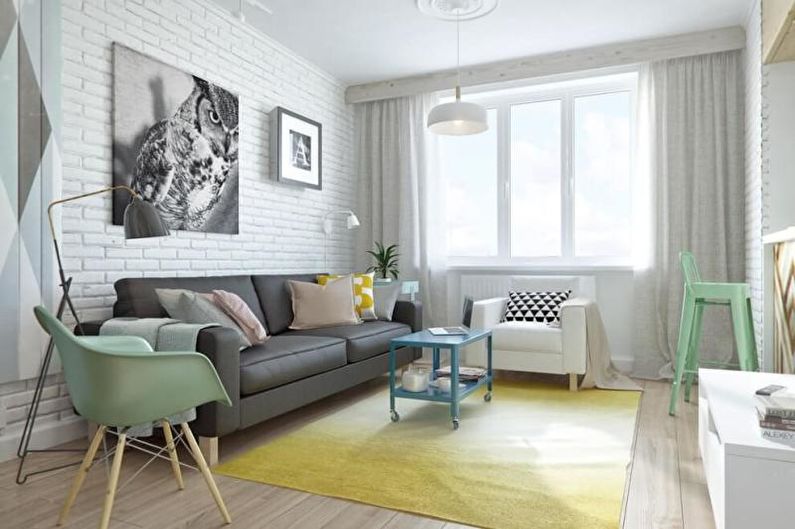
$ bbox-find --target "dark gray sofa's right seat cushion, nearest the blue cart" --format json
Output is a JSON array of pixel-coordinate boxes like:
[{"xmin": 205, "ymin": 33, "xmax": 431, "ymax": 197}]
[{"xmin": 285, "ymin": 321, "xmax": 411, "ymax": 363}]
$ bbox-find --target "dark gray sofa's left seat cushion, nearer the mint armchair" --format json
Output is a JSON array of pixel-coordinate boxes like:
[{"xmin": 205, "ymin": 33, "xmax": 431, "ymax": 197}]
[{"xmin": 240, "ymin": 334, "xmax": 347, "ymax": 395}]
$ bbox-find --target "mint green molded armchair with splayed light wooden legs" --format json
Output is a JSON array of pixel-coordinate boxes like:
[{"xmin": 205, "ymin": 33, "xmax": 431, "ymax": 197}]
[{"xmin": 34, "ymin": 307, "xmax": 232, "ymax": 529}]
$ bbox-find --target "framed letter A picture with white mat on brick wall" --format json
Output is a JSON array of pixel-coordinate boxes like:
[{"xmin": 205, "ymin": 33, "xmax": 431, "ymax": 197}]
[{"xmin": 270, "ymin": 107, "xmax": 323, "ymax": 189}]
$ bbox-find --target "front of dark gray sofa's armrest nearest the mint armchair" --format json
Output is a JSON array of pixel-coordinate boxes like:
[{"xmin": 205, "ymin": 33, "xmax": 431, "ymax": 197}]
[{"xmin": 191, "ymin": 327, "xmax": 240, "ymax": 437}]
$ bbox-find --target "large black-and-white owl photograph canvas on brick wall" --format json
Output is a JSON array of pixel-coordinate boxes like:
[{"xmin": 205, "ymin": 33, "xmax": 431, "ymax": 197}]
[{"xmin": 113, "ymin": 43, "xmax": 239, "ymax": 233}]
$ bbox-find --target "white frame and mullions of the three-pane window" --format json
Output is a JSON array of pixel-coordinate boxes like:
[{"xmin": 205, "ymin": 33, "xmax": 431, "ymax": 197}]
[{"xmin": 447, "ymin": 68, "xmax": 638, "ymax": 269}]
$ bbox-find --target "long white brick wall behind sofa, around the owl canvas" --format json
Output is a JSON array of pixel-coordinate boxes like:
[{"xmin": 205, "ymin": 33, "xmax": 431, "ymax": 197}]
[{"xmin": 0, "ymin": 0, "xmax": 356, "ymax": 460}]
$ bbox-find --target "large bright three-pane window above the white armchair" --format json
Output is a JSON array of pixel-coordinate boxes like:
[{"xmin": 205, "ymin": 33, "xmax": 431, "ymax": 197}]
[{"xmin": 439, "ymin": 73, "xmax": 637, "ymax": 266}]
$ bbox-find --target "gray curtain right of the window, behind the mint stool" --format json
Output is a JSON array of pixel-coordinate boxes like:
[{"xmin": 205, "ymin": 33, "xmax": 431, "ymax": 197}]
[{"xmin": 633, "ymin": 51, "xmax": 745, "ymax": 378}]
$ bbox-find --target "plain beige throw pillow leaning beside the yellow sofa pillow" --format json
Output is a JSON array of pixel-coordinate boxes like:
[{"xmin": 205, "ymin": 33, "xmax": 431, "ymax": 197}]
[{"xmin": 287, "ymin": 276, "xmax": 360, "ymax": 330}]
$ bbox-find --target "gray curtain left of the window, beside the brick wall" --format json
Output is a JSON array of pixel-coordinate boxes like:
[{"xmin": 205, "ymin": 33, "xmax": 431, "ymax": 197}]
[{"xmin": 355, "ymin": 95, "xmax": 446, "ymax": 324}]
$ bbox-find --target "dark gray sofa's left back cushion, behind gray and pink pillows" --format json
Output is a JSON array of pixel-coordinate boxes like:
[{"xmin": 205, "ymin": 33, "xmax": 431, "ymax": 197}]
[{"xmin": 113, "ymin": 276, "xmax": 266, "ymax": 323}]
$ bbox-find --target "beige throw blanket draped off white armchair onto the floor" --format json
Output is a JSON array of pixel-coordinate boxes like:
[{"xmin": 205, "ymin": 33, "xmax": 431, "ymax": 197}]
[{"xmin": 580, "ymin": 300, "xmax": 641, "ymax": 391}]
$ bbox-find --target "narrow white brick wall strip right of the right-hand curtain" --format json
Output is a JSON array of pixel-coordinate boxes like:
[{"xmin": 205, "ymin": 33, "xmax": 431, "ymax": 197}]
[{"xmin": 745, "ymin": 1, "xmax": 765, "ymax": 358}]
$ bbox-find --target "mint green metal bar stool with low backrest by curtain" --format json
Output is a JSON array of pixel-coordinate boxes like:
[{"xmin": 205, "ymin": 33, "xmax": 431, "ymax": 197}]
[{"xmin": 668, "ymin": 252, "xmax": 759, "ymax": 415}]
